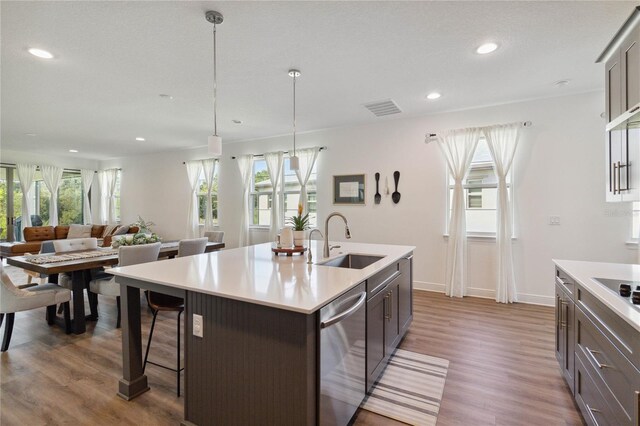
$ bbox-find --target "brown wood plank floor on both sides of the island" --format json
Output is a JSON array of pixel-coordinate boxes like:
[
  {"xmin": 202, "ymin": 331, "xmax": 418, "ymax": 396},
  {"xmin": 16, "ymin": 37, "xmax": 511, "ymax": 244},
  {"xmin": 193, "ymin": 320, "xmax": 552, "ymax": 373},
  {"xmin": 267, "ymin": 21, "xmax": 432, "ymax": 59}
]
[{"xmin": 0, "ymin": 291, "xmax": 582, "ymax": 426}]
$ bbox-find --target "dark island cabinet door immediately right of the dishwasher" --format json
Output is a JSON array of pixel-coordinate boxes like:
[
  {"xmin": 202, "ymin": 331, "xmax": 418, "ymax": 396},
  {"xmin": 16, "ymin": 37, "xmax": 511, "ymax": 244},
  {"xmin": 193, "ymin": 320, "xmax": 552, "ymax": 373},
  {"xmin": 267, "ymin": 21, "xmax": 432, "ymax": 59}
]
[{"xmin": 367, "ymin": 290, "xmax": 387, "ymax": 391}]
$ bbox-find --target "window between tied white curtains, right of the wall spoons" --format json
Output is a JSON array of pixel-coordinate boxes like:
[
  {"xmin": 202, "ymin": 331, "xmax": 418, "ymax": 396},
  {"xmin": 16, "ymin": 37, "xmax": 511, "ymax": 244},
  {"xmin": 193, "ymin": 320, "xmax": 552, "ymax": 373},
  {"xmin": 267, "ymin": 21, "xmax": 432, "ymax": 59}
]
[{"xmin": 447, "ymin": 139, "xmax": 513, "ymax": 235}]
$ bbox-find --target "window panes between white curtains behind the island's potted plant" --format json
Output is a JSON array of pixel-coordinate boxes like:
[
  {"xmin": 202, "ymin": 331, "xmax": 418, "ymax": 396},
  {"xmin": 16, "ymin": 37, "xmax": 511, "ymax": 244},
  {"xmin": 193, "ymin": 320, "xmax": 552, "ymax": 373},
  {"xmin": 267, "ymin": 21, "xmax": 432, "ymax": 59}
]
[{"xmin": 250, "ymin": 157, "xmax": 317, "ymax": 227}]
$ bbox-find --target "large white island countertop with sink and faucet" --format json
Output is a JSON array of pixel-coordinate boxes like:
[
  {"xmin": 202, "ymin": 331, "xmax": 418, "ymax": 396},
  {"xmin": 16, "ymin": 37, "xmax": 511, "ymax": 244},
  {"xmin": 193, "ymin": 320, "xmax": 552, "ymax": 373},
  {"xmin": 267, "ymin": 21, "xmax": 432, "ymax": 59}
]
[{"xmin": 108, "ymin": 241, "xmax": 415, "ymax": 314}]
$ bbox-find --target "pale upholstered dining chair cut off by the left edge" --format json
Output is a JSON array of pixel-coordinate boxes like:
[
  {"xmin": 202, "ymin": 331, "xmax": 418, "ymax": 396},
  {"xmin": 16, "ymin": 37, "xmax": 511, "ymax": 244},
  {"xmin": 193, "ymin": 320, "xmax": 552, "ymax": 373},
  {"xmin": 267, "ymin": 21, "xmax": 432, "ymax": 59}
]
[{"xmin": 0, "ymin": 264, "xmax": 71, "ymax": 352}]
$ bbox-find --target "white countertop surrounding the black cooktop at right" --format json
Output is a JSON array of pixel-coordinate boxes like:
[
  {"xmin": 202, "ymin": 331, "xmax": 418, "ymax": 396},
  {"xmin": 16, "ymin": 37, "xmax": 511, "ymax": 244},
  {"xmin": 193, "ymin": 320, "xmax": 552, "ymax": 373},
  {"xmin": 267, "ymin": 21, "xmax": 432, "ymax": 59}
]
[{"xmin": 553, "ymin": 259, "xmax": 640, "ymax": 331}]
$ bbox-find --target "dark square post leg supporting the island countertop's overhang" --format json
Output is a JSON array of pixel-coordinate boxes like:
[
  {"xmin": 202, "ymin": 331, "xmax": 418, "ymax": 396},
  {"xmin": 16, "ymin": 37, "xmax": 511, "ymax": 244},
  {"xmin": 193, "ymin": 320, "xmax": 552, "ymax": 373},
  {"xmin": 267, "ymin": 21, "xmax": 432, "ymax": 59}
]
[{"xmin": 118, "ymin": 285, "xmax": 149, "ymax": 401}]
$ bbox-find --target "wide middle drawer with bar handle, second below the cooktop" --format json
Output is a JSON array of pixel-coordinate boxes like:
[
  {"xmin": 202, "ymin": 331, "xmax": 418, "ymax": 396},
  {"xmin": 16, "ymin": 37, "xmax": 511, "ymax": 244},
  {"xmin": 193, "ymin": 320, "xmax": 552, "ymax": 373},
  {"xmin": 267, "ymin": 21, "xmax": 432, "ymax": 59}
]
[{"xmin": 576, "ymin": 309, "xmax": 640, "ymax": 425}]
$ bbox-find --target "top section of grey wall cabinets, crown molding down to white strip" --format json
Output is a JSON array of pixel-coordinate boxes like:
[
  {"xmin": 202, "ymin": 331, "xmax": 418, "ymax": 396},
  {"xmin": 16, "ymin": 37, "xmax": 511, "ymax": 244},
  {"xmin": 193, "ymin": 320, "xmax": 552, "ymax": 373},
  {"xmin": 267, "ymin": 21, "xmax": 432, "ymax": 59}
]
[{"xmin": 596, "ymin": 6, "xmax": 640, "ymax": 131}]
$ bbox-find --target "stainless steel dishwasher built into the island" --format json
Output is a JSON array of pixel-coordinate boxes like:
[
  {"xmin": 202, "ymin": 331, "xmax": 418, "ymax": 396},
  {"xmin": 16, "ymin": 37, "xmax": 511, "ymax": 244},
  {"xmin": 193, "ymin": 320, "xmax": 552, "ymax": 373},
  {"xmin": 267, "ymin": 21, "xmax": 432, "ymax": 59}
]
[{"xmin": 320, "ymin": 283, "xmax": 367, "ymax": 426}]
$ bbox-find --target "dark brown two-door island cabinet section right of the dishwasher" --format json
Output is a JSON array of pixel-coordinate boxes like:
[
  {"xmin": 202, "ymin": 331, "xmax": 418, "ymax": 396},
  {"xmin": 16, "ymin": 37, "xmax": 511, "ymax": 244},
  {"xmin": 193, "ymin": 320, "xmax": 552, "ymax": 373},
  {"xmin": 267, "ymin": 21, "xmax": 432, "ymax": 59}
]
[{"xmin": 367, "ymin": 257, "xmax": 413, "ymax": 391}]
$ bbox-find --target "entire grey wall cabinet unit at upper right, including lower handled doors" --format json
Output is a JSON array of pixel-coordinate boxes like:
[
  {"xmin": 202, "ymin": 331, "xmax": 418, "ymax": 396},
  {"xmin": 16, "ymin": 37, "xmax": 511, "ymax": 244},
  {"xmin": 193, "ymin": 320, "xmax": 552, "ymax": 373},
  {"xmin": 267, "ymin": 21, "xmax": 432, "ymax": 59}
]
[{"xmin": 597, "ymin": 6, "xmax": 640, "ymax": 202}]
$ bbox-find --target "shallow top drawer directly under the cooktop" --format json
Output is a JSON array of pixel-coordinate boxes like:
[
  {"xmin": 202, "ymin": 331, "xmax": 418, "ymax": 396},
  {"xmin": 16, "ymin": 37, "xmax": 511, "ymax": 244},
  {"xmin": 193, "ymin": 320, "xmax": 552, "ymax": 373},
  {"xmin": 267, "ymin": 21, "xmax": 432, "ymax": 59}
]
[{"xmin": 576, "ymin": 284, "xmax": 640, "ymax": 368}]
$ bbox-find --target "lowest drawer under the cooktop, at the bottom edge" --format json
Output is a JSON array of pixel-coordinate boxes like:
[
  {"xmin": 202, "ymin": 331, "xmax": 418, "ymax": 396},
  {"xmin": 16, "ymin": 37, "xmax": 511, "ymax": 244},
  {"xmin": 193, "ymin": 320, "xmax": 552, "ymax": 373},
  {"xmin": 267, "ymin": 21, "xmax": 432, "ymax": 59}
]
[{"xmin": 576, "ymin": 356, "xmax": 618, "ymax": 426}]
